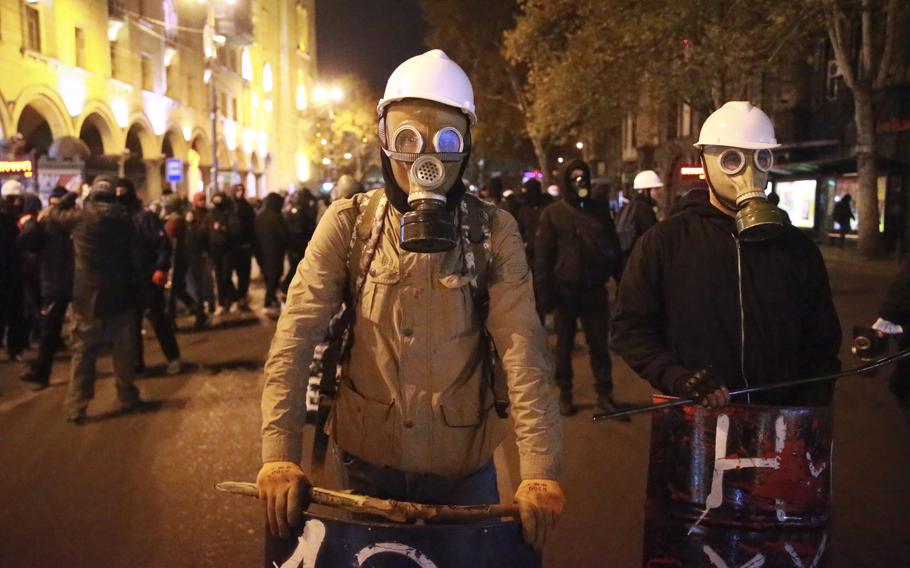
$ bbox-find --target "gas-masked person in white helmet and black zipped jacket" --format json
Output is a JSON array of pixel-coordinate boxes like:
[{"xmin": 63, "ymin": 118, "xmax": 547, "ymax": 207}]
[{"xmin": 613, "ymin": 101, "xmax": 841, "ymax": 407}]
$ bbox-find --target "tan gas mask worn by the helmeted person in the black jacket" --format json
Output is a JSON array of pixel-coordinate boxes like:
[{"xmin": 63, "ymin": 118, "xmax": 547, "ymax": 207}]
[{"xmin": 702, "ymin": 146, "xmax": 788, "ymax": 241}]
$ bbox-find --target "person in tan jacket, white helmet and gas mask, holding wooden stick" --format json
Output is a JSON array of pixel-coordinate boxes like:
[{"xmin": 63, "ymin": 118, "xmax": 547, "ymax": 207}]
[{"xmin": 257, "ymin": 50, "xmax": 565, "ymax": 549}]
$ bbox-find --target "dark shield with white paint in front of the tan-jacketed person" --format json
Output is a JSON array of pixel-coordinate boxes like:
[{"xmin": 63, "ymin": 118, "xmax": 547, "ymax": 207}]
[{"xmin": 265, "ymin": 514, "xmax": 540, "ymax": 568}]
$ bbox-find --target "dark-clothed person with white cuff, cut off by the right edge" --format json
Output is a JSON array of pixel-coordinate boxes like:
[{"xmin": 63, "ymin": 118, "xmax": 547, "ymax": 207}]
[{"xmin": 872, "ymin": 259, "xmax": 910, "ymax": 421}]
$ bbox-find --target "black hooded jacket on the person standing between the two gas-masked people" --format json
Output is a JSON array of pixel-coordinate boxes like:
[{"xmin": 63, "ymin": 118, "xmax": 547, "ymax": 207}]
[{"xmin": 534, "ymin": 161, "xmax": 620, "ymax": 310}]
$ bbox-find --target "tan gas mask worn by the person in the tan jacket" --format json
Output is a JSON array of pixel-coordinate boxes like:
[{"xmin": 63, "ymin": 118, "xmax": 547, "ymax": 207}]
[{"xmin": 379, "ymin": 99, "xmax": 469, "ymax": 253}]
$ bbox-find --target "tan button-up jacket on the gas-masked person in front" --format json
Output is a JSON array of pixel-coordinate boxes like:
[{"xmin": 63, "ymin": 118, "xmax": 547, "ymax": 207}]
[{"xmin": 262, "ymin": 194, "xmax": 562, "ymax": 479}]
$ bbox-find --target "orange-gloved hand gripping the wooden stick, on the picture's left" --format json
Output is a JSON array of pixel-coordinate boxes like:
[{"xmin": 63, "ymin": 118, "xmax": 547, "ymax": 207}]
[{"xmin": 256, "ymin": 462, "xmax": 310, "ymax": 538}]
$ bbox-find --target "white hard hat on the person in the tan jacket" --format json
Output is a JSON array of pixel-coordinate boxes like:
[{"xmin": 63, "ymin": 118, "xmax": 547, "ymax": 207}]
[{"xmin": 376, "ymin": 49, "xmax": 477, "ymax": 125}]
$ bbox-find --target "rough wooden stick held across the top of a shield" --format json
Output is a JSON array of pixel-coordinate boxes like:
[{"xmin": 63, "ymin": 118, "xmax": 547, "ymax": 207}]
[{"xmin": 215, "ymin": 481, "xmax": 518, "ymax": 523}]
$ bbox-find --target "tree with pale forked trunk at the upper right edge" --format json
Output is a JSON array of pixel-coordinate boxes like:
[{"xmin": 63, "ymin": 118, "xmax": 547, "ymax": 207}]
[{"xmin": 820, "ymin": 0, "xmax": 907, "ymax": 256}]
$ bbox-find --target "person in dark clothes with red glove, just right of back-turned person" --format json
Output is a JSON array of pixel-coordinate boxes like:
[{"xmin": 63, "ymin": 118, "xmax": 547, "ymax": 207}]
[{"xmin": 116, "ymin": 178, "xmax": 183, "ymax": 375}]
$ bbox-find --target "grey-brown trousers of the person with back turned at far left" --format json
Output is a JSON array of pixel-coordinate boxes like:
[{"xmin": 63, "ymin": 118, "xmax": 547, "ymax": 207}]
[{"xmin": 66, "ymin": 310, "xmax": 141, "ymax": 413}]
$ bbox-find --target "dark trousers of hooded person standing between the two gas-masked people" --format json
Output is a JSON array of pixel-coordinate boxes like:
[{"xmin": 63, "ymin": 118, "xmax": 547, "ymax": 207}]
[{"xmin": 556, "ymin": 286, "xmax": 613, "ymax": 396}]
